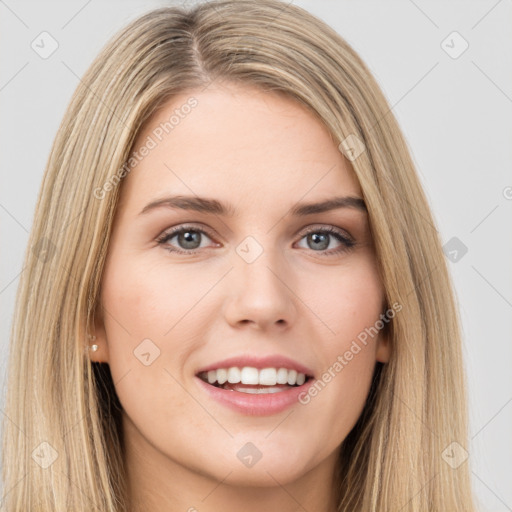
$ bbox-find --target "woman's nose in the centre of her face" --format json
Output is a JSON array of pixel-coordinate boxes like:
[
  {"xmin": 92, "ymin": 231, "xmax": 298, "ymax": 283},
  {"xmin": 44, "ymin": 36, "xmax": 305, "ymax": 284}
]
[{"xmin": 224, "ymin": 245, "xmax": 298, "ymax": 330}]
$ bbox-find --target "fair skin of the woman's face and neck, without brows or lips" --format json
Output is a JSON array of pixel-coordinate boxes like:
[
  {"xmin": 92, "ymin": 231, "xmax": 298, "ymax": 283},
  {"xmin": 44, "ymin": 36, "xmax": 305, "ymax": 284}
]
[{"xmin": 91, "ymin": 83, "xmax": 390, "ymax": 512}]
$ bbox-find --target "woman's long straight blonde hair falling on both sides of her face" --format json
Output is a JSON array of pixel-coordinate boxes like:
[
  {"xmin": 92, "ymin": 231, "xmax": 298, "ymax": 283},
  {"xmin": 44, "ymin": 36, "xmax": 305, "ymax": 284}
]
[{"xmin": 2, "ymin": 0, "xmax": 474, "ymax": 512}]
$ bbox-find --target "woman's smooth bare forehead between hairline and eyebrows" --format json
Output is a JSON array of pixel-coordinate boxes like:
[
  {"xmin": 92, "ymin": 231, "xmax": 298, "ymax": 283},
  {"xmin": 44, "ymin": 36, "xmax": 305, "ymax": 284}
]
[{"xmin": 118, "ymin": 84, "xmax": 361, "ymax": 214}]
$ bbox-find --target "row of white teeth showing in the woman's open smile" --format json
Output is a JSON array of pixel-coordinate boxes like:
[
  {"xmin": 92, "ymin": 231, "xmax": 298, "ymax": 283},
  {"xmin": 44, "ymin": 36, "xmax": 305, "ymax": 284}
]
[{"xmin": 200, "ymin": 366, "xmax": 306, "ymax": 386}]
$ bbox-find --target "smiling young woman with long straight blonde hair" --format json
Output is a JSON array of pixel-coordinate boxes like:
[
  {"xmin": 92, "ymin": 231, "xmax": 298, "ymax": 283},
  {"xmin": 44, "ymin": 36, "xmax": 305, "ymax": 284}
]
[{"xmin": 3, "ymin": 0, "xmax": 474, "ymax": 512}]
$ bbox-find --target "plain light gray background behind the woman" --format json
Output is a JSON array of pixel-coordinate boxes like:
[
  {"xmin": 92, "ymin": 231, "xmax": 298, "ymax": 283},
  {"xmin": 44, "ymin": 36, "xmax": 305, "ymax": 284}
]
[{"xmin": 0, "ymin": 0, "xmax": 512, "ymax": 512}]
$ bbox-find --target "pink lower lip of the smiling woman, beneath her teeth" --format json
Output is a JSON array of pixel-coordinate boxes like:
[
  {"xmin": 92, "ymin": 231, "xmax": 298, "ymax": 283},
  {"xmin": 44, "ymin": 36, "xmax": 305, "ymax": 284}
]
[{"xmin": 196, "ymin": 377, "xmax": 314, "ymax": 416}]
